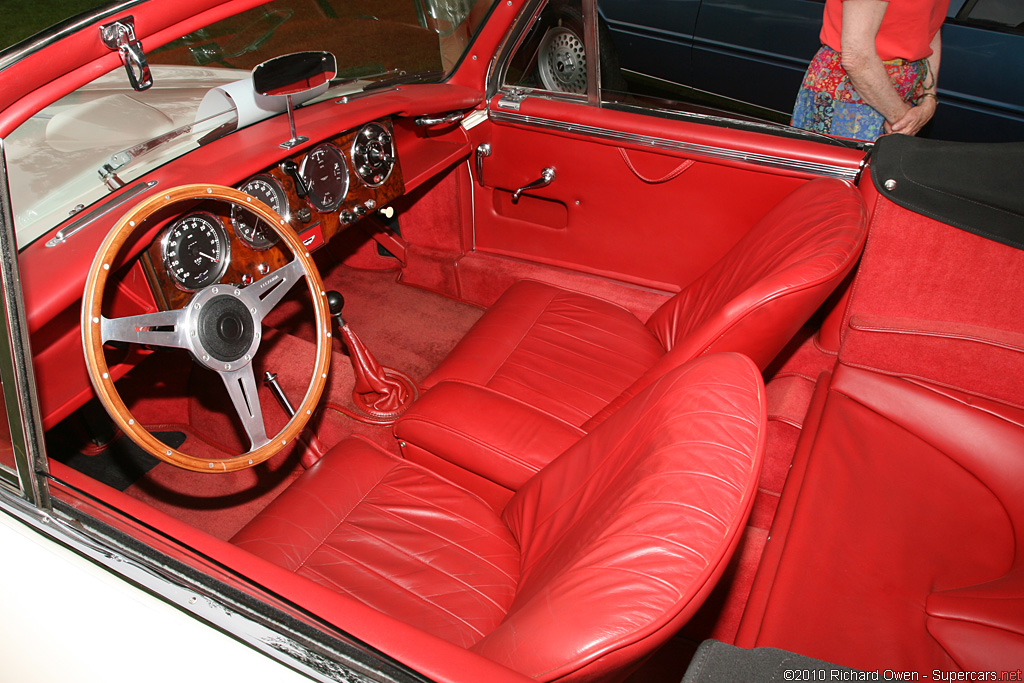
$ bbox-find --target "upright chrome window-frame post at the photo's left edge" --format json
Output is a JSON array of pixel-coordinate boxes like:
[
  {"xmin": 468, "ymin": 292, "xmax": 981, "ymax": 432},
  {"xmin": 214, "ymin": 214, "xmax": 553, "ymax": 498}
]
[{"xmin": 0, "ymin": 139, "xmax": 50, "ymax": 507}]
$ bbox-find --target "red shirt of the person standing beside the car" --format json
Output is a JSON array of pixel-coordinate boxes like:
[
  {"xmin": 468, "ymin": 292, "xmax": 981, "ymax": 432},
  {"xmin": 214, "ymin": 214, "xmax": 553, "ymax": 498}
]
[{"xmin": 821, "ymin": 0, "xmax": 949, "ymax": 61}]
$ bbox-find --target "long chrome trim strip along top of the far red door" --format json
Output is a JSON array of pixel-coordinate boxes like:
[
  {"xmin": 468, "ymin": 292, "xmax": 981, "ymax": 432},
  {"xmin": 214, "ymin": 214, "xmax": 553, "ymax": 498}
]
[{"xmin": 487, "ymin": 110, "xmax": 858, "ymax": 181}]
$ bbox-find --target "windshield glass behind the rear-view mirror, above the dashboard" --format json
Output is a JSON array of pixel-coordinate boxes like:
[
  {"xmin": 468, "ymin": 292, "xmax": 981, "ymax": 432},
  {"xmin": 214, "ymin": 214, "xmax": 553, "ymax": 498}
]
[{"xmin": 5, "ymin": 0, "xmax": 495, "ymax": 248}]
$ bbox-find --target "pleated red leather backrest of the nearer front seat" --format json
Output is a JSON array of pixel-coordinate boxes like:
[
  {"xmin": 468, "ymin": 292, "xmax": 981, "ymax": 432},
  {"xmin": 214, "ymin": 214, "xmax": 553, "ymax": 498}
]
[{"xmin": 472, "ymin": 353, "xmax": 766, "ymax": 680}]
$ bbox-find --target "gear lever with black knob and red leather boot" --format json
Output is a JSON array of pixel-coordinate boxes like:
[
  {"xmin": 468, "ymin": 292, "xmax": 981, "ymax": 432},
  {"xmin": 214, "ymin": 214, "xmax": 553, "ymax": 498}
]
[{"xmin": 327, "ymin": 291, "xmax": 418, "ymax": 424}]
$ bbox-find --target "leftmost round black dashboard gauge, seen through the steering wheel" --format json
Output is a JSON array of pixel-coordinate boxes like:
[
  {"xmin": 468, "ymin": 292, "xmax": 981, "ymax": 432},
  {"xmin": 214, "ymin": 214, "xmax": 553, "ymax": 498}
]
[{"xmin": 163, "ymin": 213, "xmax": 228, "ymax": 292}]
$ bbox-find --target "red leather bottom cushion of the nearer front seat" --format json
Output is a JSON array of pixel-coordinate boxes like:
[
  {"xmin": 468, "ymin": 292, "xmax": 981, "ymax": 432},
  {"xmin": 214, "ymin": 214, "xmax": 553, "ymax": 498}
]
[{"xmin": 231, "ymin": 438, "xmax": 519, "ymax": 647}]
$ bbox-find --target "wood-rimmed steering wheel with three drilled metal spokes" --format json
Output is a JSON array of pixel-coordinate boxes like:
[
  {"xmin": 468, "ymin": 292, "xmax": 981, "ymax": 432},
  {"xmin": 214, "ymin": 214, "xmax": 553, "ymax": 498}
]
[{"xmin": 82, "ymin": 184, "xmax": 331, "ymax": 472}]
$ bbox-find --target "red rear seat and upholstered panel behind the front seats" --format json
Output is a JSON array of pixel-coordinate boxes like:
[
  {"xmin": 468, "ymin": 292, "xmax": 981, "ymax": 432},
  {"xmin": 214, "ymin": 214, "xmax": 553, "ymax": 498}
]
[{"xmin": 736, "ymin": 184, "xmax": 1024, "ymax": 672}]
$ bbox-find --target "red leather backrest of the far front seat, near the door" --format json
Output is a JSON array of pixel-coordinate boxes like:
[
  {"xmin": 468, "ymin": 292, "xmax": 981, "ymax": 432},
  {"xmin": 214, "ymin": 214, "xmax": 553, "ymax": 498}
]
[{"xmin": 584, "ymin": 178, "xmax": 867, "ymax": 429}]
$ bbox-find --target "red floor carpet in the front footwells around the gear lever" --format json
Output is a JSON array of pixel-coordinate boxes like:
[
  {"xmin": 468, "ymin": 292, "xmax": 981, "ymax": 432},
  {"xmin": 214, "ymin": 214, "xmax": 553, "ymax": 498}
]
[{"xmin": 119, "ymin": 266, "xmax": 482, "ymax": 539}]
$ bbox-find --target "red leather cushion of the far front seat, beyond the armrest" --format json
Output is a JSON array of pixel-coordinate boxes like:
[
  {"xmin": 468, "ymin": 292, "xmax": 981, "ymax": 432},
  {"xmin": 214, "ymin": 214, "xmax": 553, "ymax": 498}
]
[{"xmin": 424, "ymin": 281, "xmax": 665, "ymax": 427}]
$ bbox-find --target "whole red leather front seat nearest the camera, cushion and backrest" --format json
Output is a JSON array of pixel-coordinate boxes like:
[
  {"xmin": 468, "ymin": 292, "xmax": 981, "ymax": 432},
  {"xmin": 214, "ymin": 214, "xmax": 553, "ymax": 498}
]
[{"xmin": 232, "ymin": 354, "xmax": 766, "ymax": 681}]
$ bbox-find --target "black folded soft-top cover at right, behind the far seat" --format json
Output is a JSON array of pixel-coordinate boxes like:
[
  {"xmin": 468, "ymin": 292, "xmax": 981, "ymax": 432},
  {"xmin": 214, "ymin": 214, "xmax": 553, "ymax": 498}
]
[{"xmin": 871, "ymin": 135, "xmax": 1024, "ymax": 249}]
